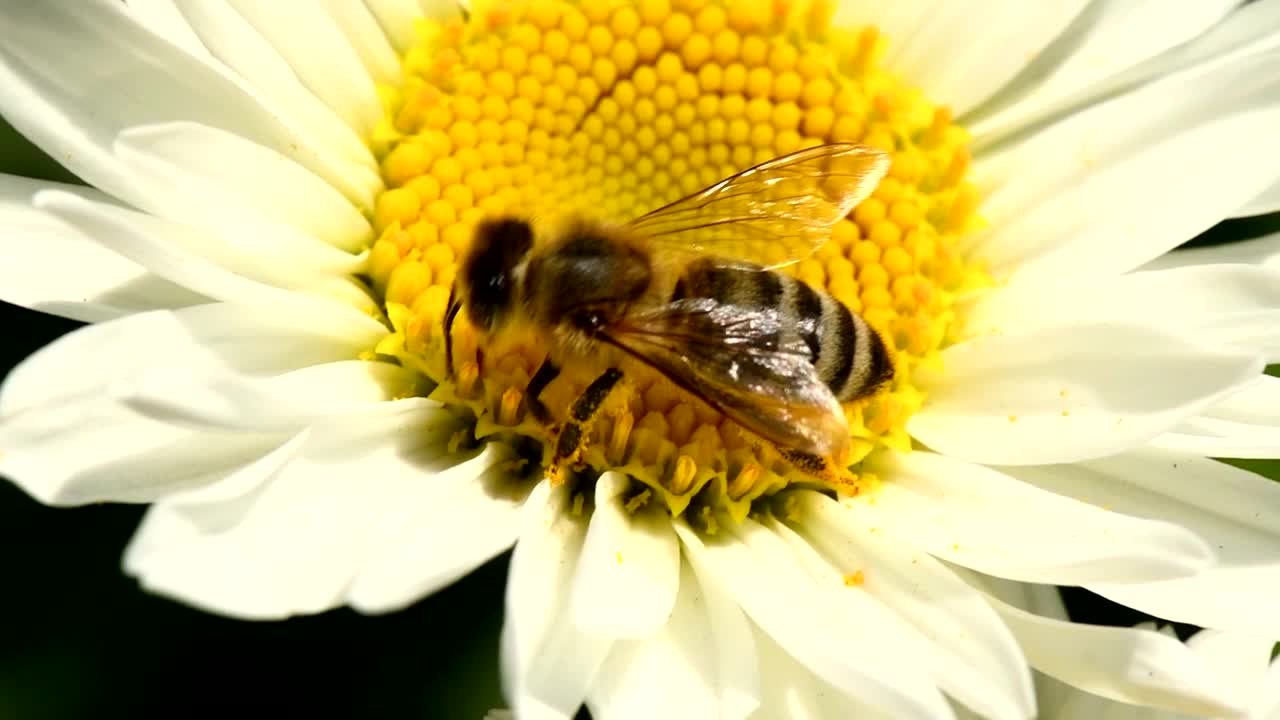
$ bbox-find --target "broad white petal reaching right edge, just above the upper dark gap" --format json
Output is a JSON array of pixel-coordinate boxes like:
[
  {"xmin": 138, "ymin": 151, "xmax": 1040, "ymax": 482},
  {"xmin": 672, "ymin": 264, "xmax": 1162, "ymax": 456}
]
[{"xmin": 974, "ymin": 54, "xmax": 1280, "ymax": 282}]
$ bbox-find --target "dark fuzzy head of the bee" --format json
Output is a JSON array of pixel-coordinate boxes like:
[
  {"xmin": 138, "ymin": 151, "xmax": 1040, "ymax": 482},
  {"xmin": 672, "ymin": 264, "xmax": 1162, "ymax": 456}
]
[{"xmin": 457, "ymin": 218, "xmax": 534, "ymax": 332}]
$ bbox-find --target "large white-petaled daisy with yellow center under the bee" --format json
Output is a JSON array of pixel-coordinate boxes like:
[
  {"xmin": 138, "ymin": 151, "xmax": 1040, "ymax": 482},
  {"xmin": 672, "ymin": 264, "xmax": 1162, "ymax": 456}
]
[{"xmin": 0, "ymin": 0, "xmax": 1280, "ymax": 719}]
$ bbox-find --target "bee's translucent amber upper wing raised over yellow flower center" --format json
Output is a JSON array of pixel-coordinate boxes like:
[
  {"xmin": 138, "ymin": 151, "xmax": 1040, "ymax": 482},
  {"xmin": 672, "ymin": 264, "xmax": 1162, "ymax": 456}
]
[{"xmin": 630, "ymin": 143, "xmax": 890, "ymax": 268}]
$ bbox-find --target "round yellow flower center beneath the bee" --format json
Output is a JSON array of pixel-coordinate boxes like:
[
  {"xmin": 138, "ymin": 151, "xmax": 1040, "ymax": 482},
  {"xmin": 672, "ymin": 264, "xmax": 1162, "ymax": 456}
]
[{"xmin": 369, "ymin": 0, "xmax": 984, "ymax": 518}]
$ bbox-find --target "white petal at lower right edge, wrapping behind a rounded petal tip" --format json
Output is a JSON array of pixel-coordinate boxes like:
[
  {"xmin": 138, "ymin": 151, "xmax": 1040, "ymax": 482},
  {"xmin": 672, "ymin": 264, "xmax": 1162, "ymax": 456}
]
[{"xmin": 1007, "ymin": 450, "xmax": 1280, "ymax": 638}]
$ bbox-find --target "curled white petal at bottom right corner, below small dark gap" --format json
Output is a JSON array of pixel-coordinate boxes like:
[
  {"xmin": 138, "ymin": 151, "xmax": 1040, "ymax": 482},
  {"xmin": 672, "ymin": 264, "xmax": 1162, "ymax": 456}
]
[{"xmin": 972, "ymin": 584, "xmax": 1239, "ymax": 715}]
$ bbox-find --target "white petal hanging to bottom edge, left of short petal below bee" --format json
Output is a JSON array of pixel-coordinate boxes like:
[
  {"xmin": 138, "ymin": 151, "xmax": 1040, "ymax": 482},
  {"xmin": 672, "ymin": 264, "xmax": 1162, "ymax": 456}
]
[{"xmin": 502, "ymin": 482, "xmax": 613, "ymax": 720}]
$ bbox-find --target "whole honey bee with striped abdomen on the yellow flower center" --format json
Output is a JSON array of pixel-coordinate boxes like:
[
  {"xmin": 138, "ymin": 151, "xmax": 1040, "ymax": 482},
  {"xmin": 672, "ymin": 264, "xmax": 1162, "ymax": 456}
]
[{"xmin": 444, "ymin": 143, "xmax": 893, "ymax": 479}]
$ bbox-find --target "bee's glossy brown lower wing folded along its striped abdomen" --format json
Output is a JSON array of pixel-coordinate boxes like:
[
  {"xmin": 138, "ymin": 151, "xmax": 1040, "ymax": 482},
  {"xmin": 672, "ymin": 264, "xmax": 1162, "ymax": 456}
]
[{"xmin": 602, "ymin": 297, "xmax": 849, "ymax": 456}]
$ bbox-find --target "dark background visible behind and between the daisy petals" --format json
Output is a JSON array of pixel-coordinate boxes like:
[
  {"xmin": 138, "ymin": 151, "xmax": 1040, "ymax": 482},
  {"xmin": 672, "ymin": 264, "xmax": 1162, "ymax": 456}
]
[{"xmin": 0, "ymin": 114, "xmax": 1280, "ymax": 720}]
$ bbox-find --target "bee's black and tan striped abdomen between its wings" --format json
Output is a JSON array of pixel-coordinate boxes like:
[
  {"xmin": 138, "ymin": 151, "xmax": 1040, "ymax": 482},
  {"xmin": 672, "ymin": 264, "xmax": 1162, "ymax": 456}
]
[{"xmin": 672, "ymin": 258, "xmax": 893, "ymax": 402}]
